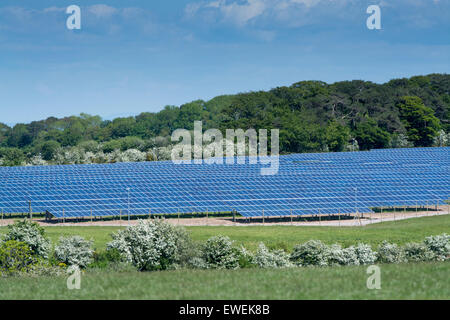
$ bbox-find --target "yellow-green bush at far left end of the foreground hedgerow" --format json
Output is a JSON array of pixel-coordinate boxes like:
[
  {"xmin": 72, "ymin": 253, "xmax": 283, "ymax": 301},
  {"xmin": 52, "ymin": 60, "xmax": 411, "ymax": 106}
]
[{"xmin": 0, "ymin": 240, "xmax": 37, "ymax": 275}]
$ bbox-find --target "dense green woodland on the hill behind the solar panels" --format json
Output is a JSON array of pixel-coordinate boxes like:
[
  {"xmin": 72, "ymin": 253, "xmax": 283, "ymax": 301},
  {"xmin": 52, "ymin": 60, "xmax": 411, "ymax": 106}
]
[{"xmin": 0, "ymin": 74, "xmax": 450, "ymax": 166}]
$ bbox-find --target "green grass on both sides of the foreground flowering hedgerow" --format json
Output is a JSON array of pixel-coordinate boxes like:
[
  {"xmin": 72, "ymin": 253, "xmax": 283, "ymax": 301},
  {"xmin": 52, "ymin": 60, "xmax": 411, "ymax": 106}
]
[{"xmin": 0, "ymin": 216, "xmax": 450, "ymax": 299}]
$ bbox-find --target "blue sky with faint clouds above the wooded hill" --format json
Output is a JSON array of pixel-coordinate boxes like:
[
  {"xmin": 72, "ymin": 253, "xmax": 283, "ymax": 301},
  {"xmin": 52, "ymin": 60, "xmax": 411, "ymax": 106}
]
[{"xmin": 0, "ymin": 0, "xmax": 450, "ymax": 124}]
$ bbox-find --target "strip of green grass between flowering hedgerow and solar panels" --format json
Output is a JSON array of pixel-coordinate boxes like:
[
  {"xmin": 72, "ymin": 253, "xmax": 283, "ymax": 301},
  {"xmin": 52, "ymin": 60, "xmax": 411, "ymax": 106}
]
[{"xmin": 0, "ymin": 215, "xmax": 450, "ymax": 250}]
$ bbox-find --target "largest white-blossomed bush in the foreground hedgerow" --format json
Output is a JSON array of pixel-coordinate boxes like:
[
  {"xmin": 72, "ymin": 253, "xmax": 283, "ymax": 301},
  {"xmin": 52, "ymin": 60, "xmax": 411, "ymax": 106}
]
[{"xmin": 107, "ymin": 220, "xmax": 192, "ymax": 271}]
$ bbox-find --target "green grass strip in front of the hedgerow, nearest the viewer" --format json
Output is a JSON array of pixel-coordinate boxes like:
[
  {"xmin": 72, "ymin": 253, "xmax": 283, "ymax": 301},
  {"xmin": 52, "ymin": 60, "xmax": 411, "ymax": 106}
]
[{"xmin": 0, "ymin": 262, "xmax": 450, "ymax": 300}]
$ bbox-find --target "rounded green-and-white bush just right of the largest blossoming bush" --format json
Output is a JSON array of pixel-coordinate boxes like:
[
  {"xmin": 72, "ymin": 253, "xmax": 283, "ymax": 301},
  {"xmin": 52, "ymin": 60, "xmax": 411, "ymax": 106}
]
[{"xmin": 202, "ymin": 236, "xmax": 239, "ymax": 269}]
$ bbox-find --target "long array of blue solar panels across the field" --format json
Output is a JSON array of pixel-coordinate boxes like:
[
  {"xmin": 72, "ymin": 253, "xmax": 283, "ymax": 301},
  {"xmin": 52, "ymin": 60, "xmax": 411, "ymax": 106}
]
[{"xmin": 0, "ymin": 147, "xmax": 450, "ymax": 217}]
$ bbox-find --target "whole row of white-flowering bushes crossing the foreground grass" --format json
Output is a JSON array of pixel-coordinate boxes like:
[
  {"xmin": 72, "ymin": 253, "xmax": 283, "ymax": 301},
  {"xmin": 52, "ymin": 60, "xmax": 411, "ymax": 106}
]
[{"xmin": 0, "ymin": 219, "xmax": 450, "ymax": 276}]
